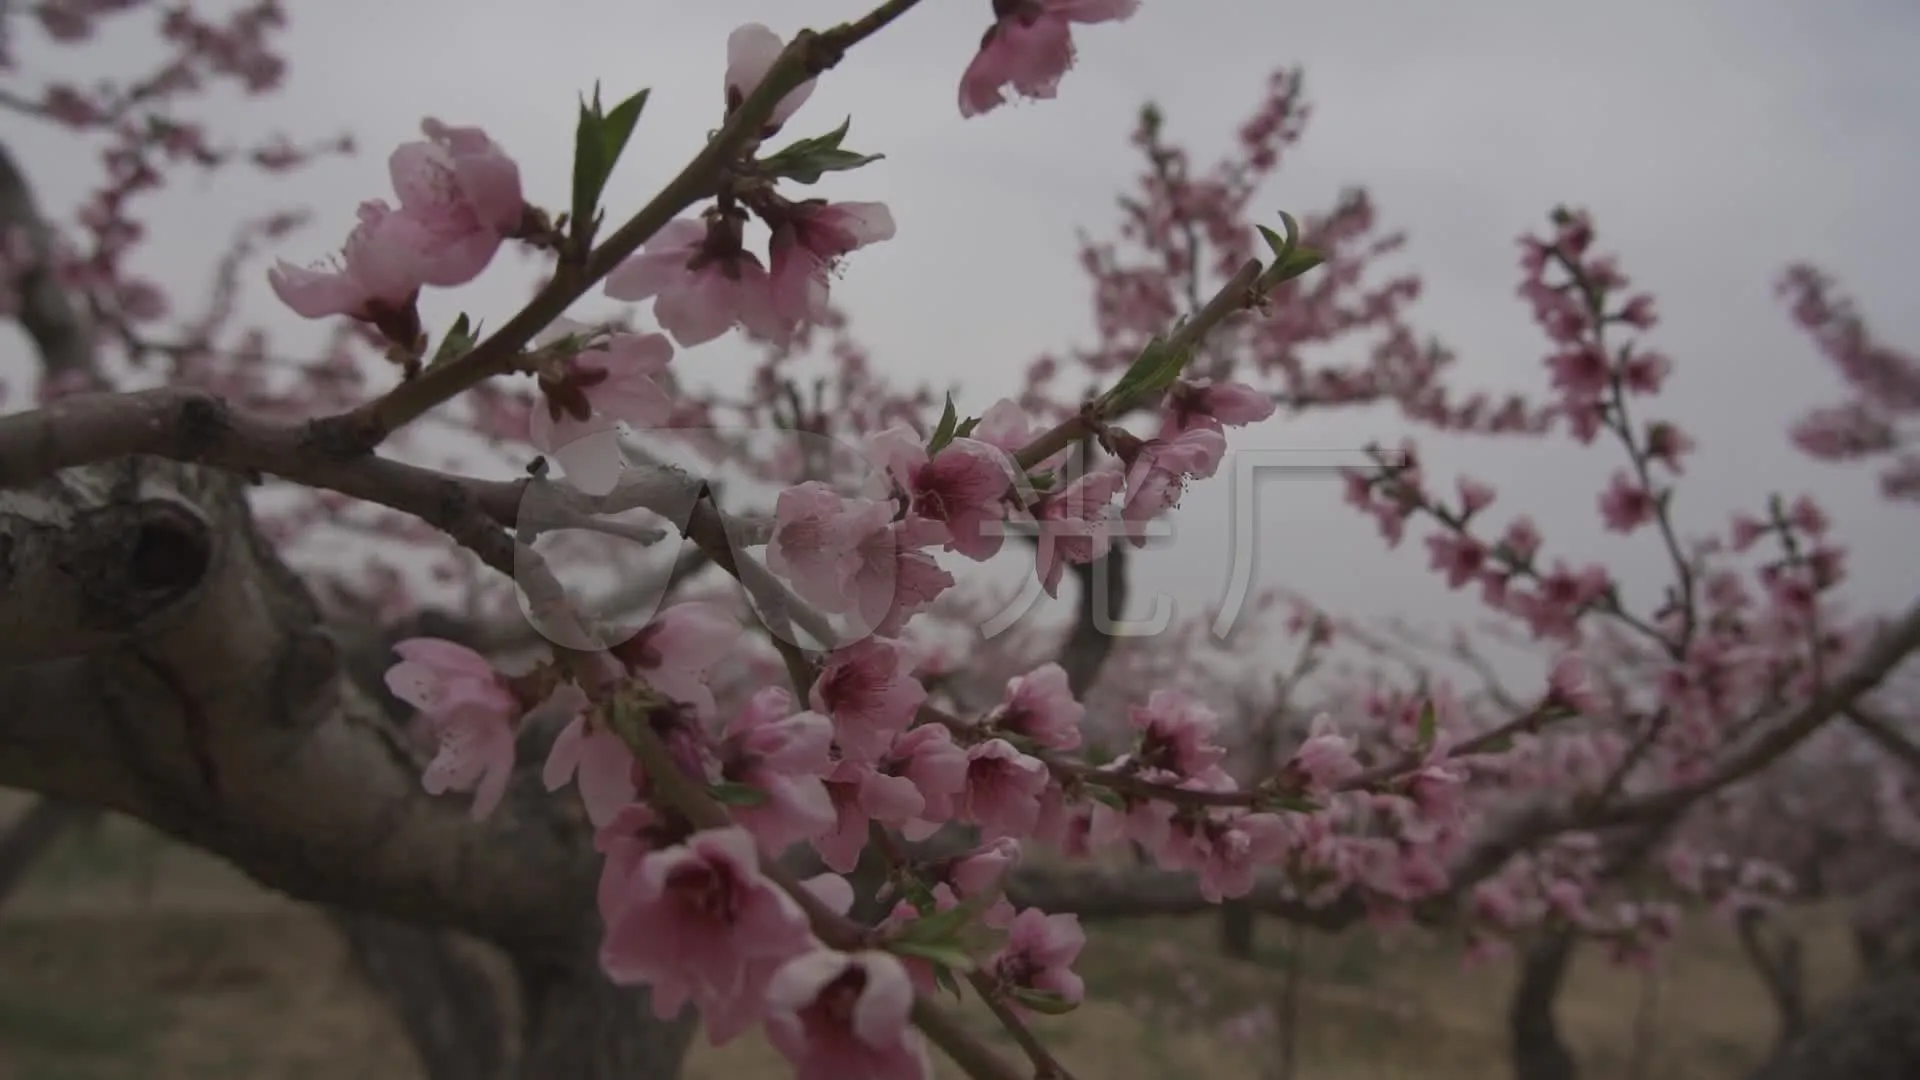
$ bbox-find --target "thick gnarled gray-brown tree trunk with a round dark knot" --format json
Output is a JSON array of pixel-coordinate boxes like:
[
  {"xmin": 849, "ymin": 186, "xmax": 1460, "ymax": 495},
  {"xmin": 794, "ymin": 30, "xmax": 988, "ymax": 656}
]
[{"xmin": 0, "ymin": 457, "xmax": 685, "ymax": 1080}]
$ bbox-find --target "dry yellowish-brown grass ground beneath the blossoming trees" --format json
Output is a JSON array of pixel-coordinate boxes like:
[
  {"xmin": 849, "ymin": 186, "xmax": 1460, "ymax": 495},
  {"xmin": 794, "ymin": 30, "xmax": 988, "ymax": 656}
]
[{"xmin": 0, "ymin": 811, "xmax": 1849, "ymax": 1080}]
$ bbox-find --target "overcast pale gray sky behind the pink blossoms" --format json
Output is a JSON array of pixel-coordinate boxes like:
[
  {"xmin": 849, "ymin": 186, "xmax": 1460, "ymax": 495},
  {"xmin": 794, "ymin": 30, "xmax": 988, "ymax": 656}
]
[{"xmin": 11, "ymin": 0, "xmax": 1920, "ymax": 680}]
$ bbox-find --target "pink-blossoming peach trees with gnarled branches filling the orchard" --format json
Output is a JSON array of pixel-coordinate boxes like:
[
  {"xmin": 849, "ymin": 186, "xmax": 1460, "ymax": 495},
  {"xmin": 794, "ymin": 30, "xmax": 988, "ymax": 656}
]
[{"xmin": 0, "ymin": 0, "xmax": 1920, "ymax": 1080}]
